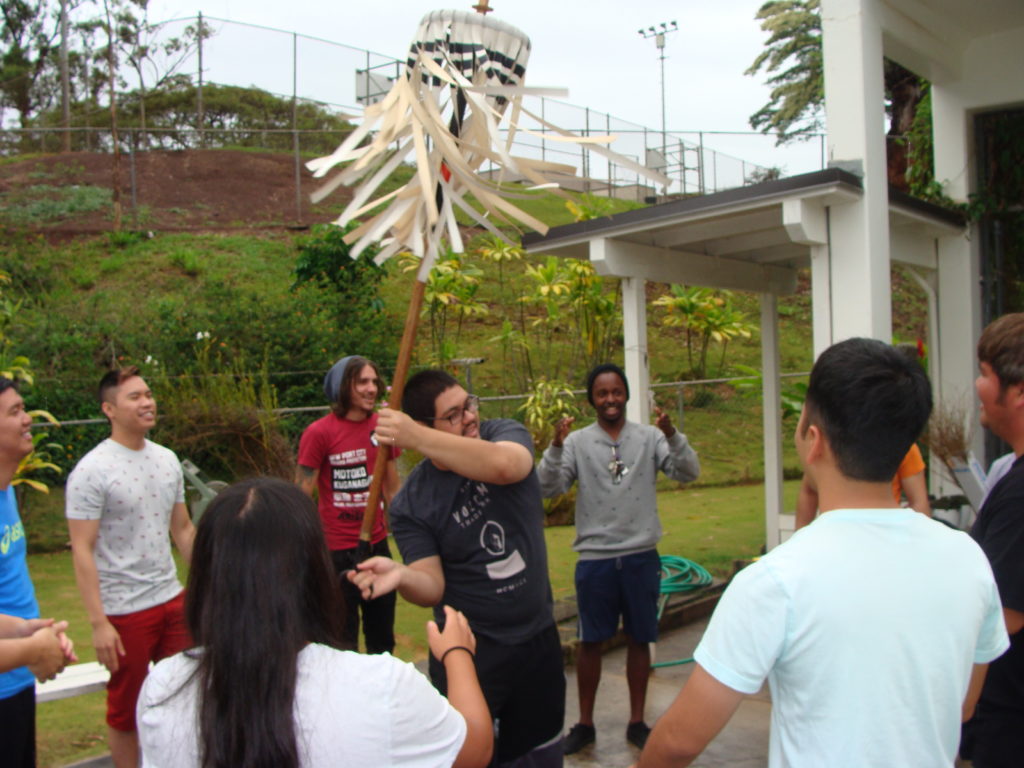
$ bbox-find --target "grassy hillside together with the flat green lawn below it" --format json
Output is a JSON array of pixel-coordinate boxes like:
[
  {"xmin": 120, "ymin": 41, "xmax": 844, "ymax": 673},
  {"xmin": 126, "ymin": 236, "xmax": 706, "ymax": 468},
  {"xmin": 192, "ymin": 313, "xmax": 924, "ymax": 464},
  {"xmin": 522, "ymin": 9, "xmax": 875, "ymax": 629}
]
[{"xmin": 0, "ymin": 152, "xmax": 926, "ymax": 765}]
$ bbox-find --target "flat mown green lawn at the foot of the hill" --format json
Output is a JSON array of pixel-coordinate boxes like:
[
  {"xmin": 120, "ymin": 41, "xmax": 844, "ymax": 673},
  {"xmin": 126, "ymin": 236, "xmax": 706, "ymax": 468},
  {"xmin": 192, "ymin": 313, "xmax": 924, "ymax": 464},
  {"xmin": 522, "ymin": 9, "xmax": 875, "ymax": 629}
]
[{"xmin": 27, "ymin": 482, "xmax": 797, "ymax": 766}]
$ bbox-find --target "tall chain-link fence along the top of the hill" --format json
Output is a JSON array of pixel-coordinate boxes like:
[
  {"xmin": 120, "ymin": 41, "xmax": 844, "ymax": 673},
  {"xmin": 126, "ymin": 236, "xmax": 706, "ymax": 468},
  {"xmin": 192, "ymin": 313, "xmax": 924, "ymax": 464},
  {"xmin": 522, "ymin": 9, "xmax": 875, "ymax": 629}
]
[{"xmin": 0, "ymin": 14, "xmax": 824, "ymax": 201}]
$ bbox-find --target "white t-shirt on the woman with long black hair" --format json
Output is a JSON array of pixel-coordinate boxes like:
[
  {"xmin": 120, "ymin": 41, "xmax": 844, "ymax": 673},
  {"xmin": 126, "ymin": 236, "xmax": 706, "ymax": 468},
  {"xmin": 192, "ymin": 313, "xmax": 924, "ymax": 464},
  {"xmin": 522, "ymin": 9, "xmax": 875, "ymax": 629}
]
[{"xmin": 137, "ymin": 644, "xmax": 466, "ymax": 768}]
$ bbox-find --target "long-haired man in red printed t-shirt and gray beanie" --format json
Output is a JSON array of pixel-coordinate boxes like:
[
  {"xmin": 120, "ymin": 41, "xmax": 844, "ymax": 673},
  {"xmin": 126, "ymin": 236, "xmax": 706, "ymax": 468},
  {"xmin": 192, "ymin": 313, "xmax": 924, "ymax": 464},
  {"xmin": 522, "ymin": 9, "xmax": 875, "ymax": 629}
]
[{"xmin": 295, "ymin": 355, "xmax": 399, "ymax": 653}]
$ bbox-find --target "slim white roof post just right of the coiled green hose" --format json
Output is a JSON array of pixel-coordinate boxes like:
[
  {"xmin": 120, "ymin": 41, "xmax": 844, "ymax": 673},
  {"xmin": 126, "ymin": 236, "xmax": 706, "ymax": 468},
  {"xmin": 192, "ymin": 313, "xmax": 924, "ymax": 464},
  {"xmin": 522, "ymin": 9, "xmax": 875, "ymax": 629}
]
[{"xmin": 760, "ymin": 293, "xmax": 783, "ymax": 549}]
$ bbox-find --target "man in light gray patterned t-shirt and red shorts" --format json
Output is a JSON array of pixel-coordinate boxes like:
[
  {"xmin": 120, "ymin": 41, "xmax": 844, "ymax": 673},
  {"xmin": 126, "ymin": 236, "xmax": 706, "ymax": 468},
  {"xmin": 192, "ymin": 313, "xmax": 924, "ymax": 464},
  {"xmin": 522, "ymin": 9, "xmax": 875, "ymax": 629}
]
[{"xmin": 66, "ymin": 367, "xmax": 196, "ymax": 768}]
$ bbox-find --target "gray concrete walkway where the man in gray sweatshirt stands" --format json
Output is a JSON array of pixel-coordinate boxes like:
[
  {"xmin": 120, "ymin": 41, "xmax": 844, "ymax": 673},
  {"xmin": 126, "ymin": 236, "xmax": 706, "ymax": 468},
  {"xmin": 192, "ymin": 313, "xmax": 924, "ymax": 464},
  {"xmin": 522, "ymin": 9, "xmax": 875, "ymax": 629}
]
[{"xmin": 565, "ymin": 618, "xmax": 771, "ymax": 768}]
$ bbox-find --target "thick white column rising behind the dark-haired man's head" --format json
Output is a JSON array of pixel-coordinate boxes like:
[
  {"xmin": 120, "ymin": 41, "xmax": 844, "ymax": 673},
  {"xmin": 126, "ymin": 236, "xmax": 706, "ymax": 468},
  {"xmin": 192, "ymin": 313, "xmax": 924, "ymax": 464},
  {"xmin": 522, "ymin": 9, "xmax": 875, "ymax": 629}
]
[{"xmin": 821, "ymin": 0, "xmax": 892, "ymax": 341}]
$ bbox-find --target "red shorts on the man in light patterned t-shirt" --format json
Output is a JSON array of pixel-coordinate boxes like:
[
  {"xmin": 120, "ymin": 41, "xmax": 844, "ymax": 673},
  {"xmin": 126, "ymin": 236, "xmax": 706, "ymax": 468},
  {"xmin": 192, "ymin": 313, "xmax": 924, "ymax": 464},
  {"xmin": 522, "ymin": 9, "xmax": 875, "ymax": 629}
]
[{"xmin": 106, "ymin": 592, "xmax": 191, "ymax": 731}]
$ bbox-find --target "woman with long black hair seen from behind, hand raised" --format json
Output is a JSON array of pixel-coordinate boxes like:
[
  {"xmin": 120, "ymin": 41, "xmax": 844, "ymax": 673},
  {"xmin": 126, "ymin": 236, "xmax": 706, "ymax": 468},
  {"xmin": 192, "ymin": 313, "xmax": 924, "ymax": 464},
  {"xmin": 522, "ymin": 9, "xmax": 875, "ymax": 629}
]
[{"xmin": 138, "ymin": 478, "xmax": 493, "ymax": 768}]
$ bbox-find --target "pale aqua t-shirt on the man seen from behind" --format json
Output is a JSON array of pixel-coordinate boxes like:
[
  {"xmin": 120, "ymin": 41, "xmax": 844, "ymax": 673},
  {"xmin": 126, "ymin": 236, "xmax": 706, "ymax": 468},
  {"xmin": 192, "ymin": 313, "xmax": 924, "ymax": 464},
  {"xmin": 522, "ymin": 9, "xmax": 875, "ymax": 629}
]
[{"xmin": 694, "ymin": 509, "xmax": 1009, "ymax": 768}]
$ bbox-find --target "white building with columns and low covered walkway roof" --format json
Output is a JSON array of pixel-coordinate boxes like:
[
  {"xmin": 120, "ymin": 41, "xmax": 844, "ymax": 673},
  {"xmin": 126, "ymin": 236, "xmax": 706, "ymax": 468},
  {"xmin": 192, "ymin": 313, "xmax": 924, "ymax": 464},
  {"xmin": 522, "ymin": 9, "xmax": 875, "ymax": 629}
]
[{"xmin": 523, "ymin": 0, "xmax": 1024, "ymax": 547}]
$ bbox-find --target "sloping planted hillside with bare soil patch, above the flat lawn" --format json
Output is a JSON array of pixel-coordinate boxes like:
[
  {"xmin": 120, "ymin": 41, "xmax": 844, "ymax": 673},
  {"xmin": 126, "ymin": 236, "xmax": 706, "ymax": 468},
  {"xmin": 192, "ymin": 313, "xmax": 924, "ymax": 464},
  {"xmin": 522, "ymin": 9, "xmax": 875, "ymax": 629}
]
[{"xmin": 0, "ymin": 151, "xmax": 925, "ymax": 512}]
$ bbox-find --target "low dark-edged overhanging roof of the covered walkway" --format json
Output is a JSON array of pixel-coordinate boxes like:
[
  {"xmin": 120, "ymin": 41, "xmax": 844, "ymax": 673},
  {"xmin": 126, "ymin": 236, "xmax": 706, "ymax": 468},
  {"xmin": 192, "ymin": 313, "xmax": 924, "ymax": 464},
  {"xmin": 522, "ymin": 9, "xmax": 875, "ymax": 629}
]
[{"xmin": 522, "ymin": 168, "xmax": 965, "ymax": 294}]
